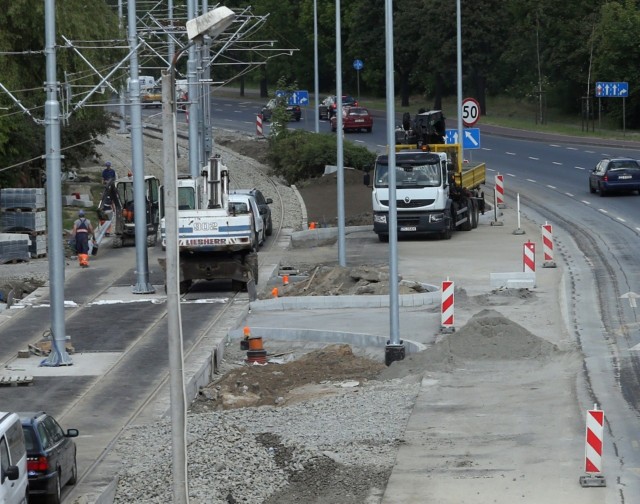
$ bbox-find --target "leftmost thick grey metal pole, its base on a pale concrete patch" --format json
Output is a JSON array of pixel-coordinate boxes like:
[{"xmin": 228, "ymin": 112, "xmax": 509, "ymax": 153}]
[{"xmin": 42, "ymin": 0, "xmax": 73, "ymax": 366}]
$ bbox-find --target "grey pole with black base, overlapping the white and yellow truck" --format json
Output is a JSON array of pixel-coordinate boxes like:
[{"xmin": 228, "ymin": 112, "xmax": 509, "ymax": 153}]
[{"xmin": 384, "ymin": 0, "xmax": 404, "ymax": 364}]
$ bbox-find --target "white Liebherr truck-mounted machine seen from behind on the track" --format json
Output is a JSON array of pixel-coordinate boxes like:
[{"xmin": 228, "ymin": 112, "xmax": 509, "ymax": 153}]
[{"xmin": 159, "ymin": 156, "xmax": 260, "ymax": 293}]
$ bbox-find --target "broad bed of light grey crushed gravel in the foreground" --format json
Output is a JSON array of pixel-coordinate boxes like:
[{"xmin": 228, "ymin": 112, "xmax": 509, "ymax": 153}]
[{"xmin": 115, "ymin": 379, "xmax": 420, "ymax": 504}]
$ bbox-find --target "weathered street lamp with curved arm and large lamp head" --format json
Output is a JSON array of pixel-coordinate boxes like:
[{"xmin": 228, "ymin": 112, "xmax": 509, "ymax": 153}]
[{"xmin": 162, "ymin": 7, "xmax": 235, "ymax": 504}]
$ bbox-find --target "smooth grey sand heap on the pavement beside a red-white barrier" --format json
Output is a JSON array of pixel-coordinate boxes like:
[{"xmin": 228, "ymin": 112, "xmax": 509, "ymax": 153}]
[{"xmin": 380, "ymin": 310, "xmax": 559, "ymax": 379}]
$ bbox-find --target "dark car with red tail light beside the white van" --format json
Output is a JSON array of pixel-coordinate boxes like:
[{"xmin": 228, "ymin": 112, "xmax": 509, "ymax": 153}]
[{"xmin": 18, "ymin": 411, "xmax": 78, "ymax": 504}]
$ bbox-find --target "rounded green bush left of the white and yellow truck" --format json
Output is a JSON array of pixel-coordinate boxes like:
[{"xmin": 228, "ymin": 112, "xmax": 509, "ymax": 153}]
[{"xmin": 269, "ymin": 130, "xmax": 376, "ymax": 184}]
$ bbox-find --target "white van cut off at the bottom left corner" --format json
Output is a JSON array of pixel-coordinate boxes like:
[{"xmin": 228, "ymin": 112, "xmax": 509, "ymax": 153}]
[{"xmin": 0, "ymin": 411, "xmax": 29, "ymax": 504}]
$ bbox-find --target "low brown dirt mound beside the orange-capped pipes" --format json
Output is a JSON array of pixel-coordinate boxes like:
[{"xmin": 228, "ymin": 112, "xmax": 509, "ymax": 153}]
[{"xmin": 191, "ymin": 342, "xmax": 385, "ymax": 411}]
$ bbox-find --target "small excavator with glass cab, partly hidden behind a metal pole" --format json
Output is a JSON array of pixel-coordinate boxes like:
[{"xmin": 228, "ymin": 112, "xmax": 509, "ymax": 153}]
[{"xmin": 98, "ymin": 175, "xmax": 160, "ymax": 248}]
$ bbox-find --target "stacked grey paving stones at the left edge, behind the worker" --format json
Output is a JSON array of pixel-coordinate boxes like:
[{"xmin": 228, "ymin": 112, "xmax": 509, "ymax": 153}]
[{"xmin": 0, "ymin": 188, "xmax": 47, "ymax": 262}]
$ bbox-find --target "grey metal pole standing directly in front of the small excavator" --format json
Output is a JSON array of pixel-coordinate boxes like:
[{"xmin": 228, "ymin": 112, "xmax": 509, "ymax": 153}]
[{"xmin": 127, "ymin": 0, "xmax": 155, "ymax": 294}]
